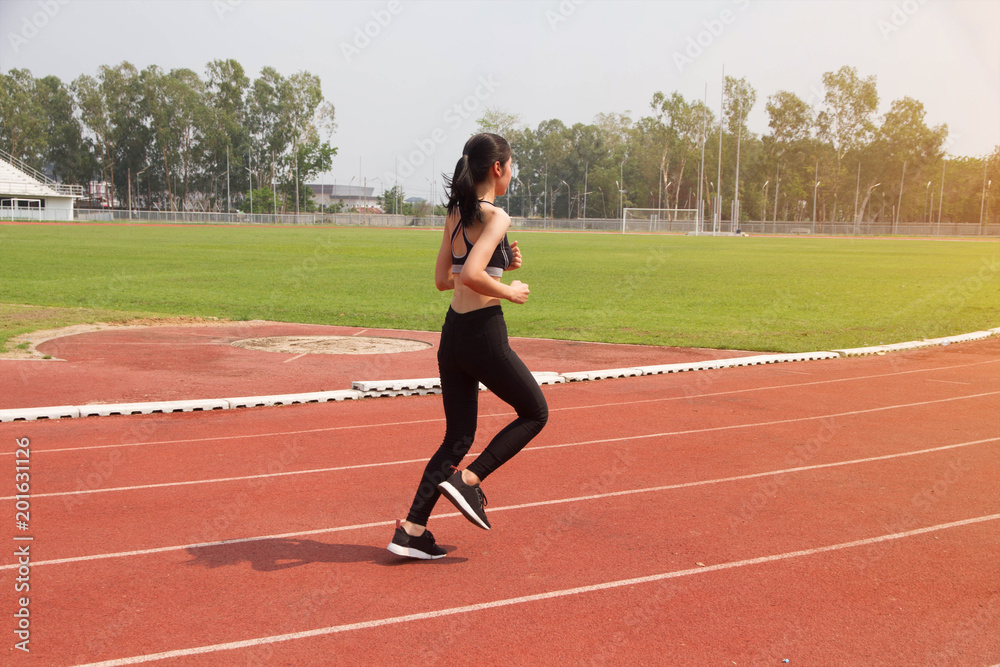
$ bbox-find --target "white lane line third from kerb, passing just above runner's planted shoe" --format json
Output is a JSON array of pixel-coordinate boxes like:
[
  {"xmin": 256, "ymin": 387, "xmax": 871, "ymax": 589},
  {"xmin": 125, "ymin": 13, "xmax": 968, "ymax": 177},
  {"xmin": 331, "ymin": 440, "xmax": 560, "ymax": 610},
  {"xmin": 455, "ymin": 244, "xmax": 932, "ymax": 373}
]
[{"xmin": 0, "ymin": 437, "xmax": 1000, "ymax": 571}]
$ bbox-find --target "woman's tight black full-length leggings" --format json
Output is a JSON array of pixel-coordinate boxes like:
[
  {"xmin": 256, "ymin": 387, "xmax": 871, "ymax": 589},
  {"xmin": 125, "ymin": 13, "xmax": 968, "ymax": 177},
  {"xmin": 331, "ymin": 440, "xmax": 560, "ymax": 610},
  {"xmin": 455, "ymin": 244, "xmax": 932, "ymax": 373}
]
[{"xmin": 406, "ymin": 306, "xmax": 549, "ymax": 526}]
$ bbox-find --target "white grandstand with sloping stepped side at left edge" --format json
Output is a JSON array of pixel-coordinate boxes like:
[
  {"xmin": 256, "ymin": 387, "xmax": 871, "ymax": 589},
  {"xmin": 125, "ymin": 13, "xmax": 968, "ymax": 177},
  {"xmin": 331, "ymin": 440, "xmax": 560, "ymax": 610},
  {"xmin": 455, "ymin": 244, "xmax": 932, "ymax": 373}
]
[{"xmin": 0, "ymin": 150, "xmax": 83, "ymax": 221}]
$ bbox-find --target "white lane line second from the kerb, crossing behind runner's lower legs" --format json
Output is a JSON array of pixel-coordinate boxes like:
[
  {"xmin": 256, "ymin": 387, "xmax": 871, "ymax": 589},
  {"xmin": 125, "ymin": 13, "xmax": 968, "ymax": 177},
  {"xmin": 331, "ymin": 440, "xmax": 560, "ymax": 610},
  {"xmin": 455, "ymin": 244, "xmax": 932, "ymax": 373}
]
[{"xmin": 0, "ymin": 391, "xmax": 1000, "ymax": 500}]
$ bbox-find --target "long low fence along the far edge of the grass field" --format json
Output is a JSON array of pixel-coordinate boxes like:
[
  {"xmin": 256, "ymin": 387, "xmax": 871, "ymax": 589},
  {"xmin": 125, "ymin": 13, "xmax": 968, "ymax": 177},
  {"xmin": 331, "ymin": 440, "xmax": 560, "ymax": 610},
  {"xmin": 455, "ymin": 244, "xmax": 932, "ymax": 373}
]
[{"xmin": 39, "ymin": 209, "xmax": 1000, "ymax": 237}]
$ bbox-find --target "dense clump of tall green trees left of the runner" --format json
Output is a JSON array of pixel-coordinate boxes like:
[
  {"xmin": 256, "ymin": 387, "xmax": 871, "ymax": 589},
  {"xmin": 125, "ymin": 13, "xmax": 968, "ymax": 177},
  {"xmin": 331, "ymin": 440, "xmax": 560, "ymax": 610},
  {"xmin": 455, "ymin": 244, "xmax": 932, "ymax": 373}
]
[{"xmin": 0, "ymin": 59, "xmax": 337, "ymax": 213}]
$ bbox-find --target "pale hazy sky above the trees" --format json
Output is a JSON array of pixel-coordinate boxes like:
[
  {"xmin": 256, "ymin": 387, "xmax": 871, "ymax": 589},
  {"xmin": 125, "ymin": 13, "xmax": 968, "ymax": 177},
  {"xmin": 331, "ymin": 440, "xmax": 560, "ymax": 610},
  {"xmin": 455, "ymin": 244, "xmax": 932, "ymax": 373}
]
[{"xmin": 0, "ymin": 0, "xmax": 1000, "ymax": 204}]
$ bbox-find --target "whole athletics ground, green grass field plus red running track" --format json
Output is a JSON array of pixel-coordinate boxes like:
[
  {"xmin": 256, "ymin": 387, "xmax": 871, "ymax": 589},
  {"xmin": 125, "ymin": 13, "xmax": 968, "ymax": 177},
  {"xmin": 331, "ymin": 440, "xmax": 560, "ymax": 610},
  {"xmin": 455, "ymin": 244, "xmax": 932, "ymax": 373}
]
[{"xmin": 0, "ymin": 225, "xmax": 1000, "ymax": 667}]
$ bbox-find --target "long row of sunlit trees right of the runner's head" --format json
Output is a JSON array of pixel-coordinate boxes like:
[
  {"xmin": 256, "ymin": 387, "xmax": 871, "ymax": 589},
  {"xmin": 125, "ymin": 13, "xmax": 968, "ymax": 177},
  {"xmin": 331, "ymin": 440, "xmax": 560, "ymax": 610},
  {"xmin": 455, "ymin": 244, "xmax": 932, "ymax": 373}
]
[{"xmin": 479, "ymin": 66, "xmax": 1000, "ymax": 228}]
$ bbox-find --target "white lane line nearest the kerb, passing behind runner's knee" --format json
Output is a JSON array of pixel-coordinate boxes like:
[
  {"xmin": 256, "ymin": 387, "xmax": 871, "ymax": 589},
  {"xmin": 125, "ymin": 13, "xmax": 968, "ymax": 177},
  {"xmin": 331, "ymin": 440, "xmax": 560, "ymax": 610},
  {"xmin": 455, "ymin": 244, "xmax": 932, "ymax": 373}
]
[{"xmin": 7, "ymin": 359, "xmax": 1000, "ymax": 456}]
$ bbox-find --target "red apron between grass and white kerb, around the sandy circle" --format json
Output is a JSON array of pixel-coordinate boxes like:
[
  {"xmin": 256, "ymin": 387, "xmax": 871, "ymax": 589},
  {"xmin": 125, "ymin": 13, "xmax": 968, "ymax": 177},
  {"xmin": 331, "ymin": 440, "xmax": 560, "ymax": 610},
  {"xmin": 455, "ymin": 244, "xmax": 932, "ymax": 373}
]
[{"xmin": 0, "ymin": 322, "xmax": 757, "ymax": 409}]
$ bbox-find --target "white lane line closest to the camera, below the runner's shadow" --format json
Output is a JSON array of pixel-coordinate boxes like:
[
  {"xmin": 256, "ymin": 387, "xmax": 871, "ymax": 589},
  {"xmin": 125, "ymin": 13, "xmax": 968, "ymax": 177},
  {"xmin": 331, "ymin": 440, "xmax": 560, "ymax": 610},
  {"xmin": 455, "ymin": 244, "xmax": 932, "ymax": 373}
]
[{"xmin": 78, "ymin": 514, "xmax": 1000, "ymax": 667}]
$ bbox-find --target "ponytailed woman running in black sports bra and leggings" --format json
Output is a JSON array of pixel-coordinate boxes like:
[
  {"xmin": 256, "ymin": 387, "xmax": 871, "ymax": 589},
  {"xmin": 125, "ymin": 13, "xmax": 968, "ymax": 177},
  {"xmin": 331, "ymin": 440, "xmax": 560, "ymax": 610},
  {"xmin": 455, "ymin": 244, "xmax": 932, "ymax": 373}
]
[{"xmin": 388, "ymin": 134, "xmax": 549, "ymax": 558}]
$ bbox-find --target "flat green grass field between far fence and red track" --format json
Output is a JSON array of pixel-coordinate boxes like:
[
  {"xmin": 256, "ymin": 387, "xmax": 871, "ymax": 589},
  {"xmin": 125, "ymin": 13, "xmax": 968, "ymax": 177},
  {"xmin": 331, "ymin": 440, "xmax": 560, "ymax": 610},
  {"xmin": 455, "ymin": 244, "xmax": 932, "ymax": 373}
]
[{"xmin": 0, "ymin": 225, "xmax": 1000, "ymax": 352}]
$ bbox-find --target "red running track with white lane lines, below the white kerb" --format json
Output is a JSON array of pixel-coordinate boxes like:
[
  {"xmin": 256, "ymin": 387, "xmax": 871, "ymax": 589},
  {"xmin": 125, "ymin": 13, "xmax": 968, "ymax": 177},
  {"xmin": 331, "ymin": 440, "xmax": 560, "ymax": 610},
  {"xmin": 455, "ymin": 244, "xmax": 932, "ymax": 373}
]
[{"xmin": 0, "ymin": 337, "xmax": 1000, "ymax": 666}]
